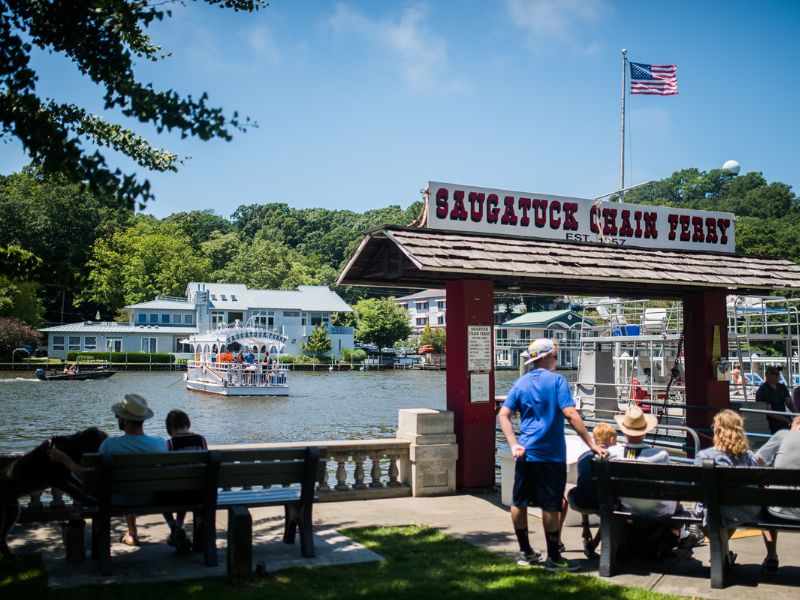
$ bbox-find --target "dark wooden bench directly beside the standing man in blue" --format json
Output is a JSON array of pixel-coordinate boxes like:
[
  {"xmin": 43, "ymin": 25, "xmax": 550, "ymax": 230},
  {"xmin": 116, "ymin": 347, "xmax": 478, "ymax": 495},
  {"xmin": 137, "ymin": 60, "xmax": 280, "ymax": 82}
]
[{"xmin": 594, "ymin": 457, "xmax": 705, "ymax": 577}]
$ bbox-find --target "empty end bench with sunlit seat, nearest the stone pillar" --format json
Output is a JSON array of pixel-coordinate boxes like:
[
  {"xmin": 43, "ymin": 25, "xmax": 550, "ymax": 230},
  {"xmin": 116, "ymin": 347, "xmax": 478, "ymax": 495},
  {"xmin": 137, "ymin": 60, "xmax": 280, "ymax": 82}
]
[{"xmin": 217, "ymin": 447, "xmax": 325, "ymax": 576}]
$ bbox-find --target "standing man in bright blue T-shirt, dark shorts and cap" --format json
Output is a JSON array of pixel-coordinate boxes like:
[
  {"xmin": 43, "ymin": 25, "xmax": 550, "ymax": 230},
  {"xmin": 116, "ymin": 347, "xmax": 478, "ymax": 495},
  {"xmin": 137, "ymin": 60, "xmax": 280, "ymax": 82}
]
[{"xmin": 497, "ymin": 338, "xmax": 607, "ymax": 571}]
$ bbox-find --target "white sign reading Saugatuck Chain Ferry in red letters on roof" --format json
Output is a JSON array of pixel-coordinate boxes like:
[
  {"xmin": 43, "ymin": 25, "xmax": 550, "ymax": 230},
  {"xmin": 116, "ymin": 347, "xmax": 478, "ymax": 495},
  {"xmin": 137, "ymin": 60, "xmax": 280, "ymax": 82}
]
[{"xmin": 427, "ymin": 181, "xmax": 736, "ymax": 252}]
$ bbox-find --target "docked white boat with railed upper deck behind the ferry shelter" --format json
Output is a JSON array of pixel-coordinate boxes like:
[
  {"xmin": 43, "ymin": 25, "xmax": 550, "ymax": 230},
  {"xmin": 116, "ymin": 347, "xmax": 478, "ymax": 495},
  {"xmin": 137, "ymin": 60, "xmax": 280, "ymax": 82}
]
[{"xmin": 575, "ymin": 296, "xmax": 800, "ymax": 437}]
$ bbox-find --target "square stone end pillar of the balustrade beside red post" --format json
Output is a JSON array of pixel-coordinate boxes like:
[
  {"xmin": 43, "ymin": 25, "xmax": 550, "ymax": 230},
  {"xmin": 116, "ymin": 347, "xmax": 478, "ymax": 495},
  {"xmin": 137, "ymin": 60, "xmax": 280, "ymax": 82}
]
[{"xmin": 397, "ymin": 408, "xmax": 458, "ymax": 497}]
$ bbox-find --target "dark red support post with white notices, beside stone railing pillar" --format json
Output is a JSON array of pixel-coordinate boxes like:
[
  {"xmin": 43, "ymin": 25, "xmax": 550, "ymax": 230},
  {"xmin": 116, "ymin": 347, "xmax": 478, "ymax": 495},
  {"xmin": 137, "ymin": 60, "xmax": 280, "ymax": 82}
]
[{"xmin": 446, "ymin": 280, "xmax": 495, "ymax": 489}]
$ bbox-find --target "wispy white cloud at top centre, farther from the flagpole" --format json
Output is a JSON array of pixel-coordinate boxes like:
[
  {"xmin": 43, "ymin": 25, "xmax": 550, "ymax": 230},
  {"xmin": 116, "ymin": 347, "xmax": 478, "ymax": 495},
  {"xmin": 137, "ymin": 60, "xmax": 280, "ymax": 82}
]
[{"xmin": 330, "ymin": 4, "xmax": 465, "ymax": 90}]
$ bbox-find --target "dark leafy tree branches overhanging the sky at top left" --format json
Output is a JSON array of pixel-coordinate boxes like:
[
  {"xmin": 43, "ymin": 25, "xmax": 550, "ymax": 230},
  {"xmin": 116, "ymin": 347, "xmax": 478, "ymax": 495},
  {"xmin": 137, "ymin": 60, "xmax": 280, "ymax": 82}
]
[{"xmin": 0, "ymin": 0, "xmax": 266, "ymax": 208}]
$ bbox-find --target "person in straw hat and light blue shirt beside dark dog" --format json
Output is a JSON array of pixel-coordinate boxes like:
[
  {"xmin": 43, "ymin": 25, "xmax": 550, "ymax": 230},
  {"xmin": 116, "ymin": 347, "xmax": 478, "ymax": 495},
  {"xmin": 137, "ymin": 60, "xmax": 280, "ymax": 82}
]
[{"xmin": 98, "ymin": 394, "xmax": 167, "ymax": 546}]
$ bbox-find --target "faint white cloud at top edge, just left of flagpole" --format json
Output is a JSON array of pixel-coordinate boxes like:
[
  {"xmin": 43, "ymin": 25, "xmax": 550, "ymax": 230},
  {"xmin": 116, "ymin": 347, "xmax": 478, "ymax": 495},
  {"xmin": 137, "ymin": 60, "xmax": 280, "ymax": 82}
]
[{"xmin": 506, "ymin": 0, "xmax": 609, "ymax": 55}]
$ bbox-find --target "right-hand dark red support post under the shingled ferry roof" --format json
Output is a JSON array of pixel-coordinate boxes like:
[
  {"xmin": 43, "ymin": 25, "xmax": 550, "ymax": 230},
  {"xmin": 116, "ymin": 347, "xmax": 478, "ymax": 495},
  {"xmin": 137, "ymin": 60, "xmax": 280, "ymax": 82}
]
[{"xmin": 683, "ymin": 292, "xmax": 731, "ymax": 447}]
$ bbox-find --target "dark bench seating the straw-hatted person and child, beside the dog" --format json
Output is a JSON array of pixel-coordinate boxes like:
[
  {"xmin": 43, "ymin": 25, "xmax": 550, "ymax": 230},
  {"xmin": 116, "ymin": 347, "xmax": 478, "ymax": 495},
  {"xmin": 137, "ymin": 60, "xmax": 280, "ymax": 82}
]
[{"xmin": 82, "ymin": 451, "xmax": 221, "ymax": 575}]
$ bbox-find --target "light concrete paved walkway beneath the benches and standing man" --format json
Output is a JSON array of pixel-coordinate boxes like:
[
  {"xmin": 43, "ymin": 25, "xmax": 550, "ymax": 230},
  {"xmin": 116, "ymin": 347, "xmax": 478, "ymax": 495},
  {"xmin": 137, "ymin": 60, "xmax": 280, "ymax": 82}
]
[{"xmin": 7, "ymin": 493, "xmax": 800, "ymax": 600}]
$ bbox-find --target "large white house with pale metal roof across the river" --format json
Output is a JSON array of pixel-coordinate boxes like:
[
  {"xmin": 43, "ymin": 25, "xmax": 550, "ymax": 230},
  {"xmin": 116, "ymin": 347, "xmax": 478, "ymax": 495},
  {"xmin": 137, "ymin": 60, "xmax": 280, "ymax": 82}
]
[{"xmin": 42, "ymin": 282, "xmax": 354, "ymax": 358}]
